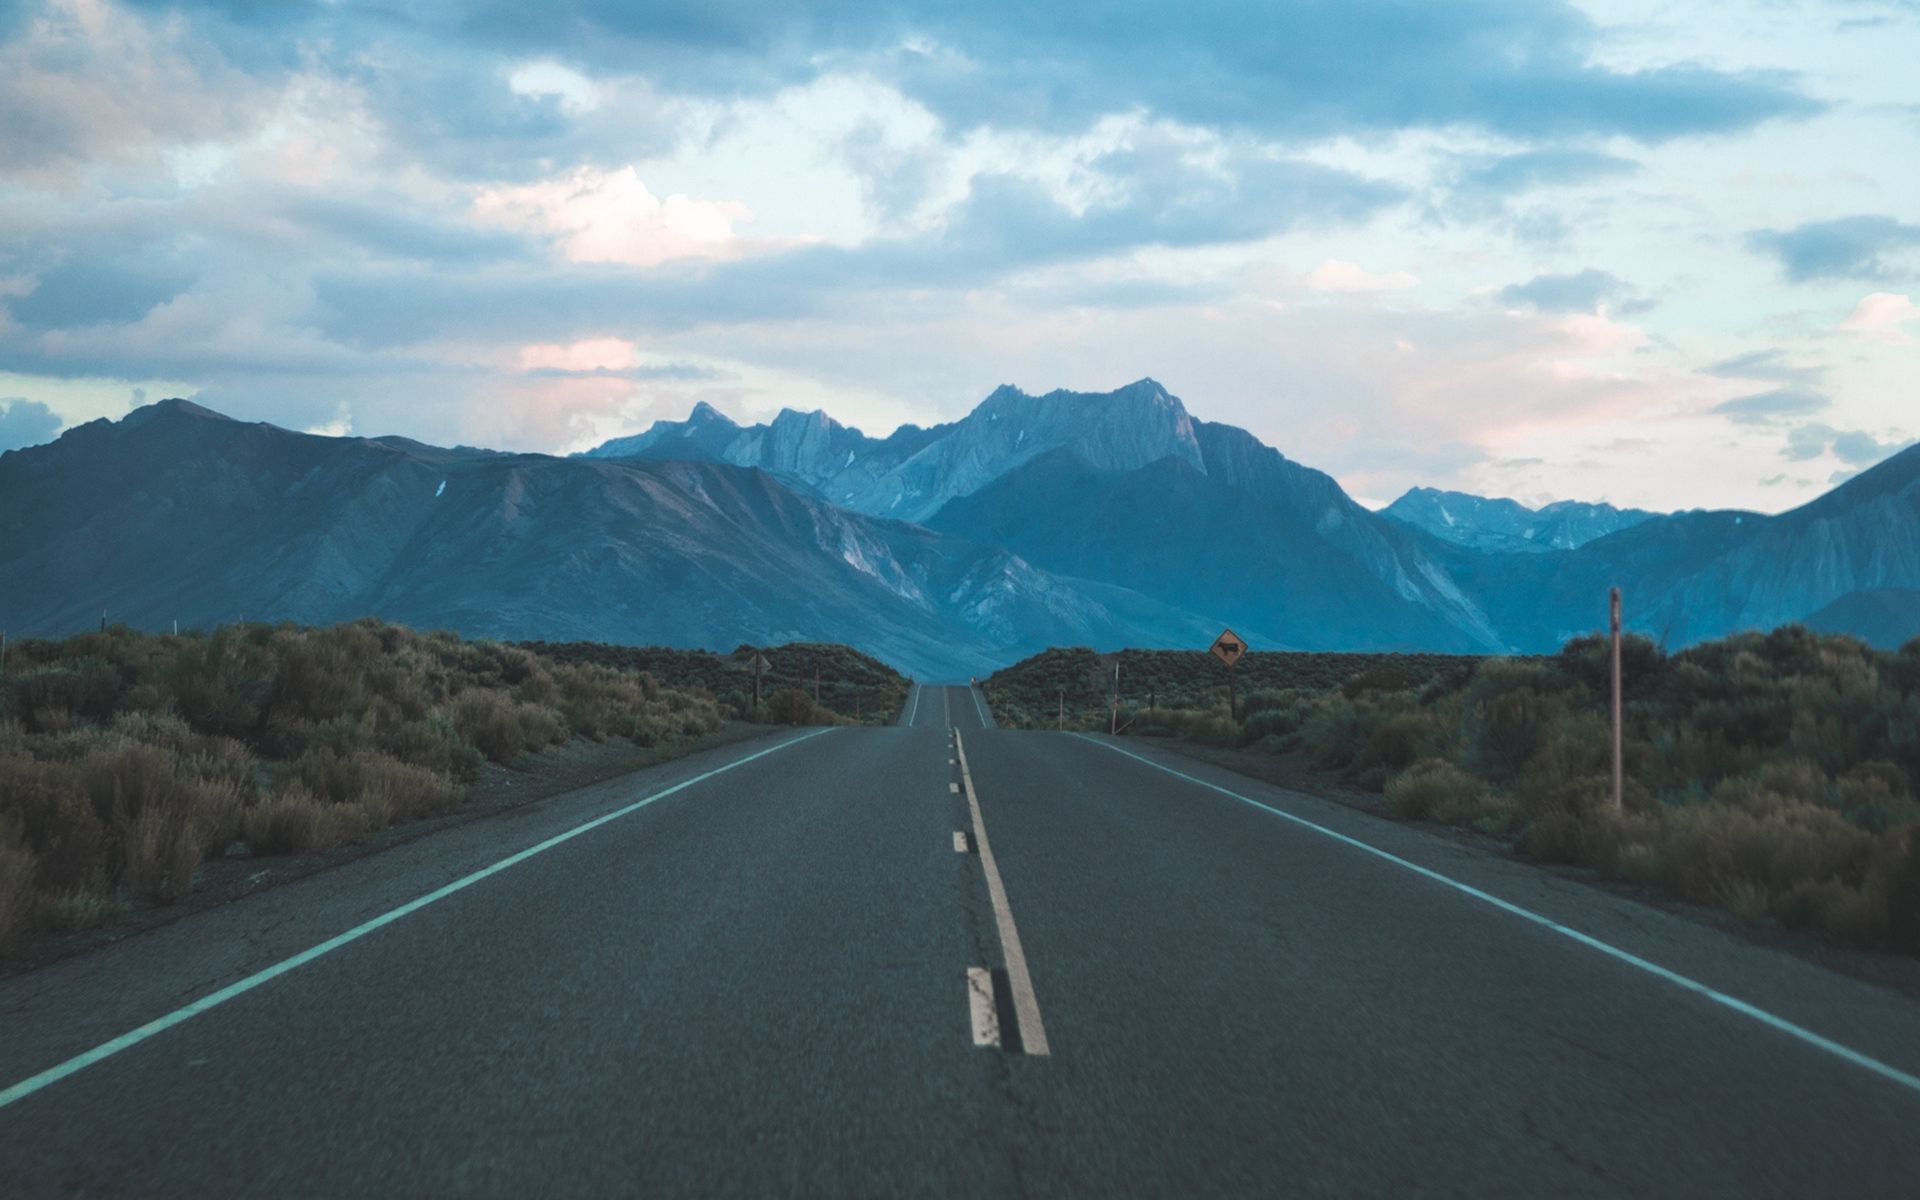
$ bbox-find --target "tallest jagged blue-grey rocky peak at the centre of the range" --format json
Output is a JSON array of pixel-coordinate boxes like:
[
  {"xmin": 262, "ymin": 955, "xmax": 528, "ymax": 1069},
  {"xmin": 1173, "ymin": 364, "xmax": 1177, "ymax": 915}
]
[{"xmin": 589, "ymin": 378, "xmax": 1503, "ymax": 651}]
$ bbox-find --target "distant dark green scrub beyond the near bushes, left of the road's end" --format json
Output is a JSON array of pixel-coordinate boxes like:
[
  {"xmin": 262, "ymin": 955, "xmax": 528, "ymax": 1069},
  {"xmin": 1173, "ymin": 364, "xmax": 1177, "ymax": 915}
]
[{"xmin": 520, "ymin": 641, "xmax": 912, "ymax": 726}]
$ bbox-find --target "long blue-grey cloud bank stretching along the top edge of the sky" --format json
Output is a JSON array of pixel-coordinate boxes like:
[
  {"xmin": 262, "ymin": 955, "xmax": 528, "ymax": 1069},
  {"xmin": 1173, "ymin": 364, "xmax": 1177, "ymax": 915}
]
[{"xmin": 101, "ymin": 0, "xmax": 1822, "ymax": 142}]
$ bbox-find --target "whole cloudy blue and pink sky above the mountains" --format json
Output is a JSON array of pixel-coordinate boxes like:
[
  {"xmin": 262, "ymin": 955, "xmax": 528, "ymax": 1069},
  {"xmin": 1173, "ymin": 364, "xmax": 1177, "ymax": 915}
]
[{"xmin": 0, "ymin": 0, "xmax": 1920, "ymax": 511}]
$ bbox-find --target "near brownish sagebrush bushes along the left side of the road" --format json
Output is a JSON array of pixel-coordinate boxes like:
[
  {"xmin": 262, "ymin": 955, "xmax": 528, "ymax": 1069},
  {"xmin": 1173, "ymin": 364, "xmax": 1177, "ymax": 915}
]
[{"xmin": 0, "ymin": 620, "xmax": 728, "ymax": 947}]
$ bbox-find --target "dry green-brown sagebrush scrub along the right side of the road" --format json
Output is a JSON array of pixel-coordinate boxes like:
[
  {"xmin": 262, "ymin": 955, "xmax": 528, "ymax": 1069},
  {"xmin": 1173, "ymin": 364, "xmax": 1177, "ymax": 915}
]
[{"xmin": 985, "ymin": 626, "xmax": 1920, "ymax": 954}]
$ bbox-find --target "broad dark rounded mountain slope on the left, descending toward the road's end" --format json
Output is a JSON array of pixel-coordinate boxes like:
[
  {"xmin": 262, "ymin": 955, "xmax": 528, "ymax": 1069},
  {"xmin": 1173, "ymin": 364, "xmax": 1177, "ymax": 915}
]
[{"xmin": 0, "ymin": 401, "xmax": 1210, "ymax": 676}]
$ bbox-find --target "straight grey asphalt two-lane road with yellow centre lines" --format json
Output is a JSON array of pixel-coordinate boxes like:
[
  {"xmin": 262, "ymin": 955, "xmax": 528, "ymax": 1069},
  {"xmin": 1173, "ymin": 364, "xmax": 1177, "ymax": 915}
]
[{"xmin": 0, "ymin": 685, "xmax": 1920, "ymax": 1198}]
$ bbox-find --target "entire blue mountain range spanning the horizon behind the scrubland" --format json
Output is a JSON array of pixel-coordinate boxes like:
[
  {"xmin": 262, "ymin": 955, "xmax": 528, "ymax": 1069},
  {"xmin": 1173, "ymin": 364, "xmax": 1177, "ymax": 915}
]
[{"xmin": 0, "ymin": 380, "xmax": 1920, "ymax": 678}]
